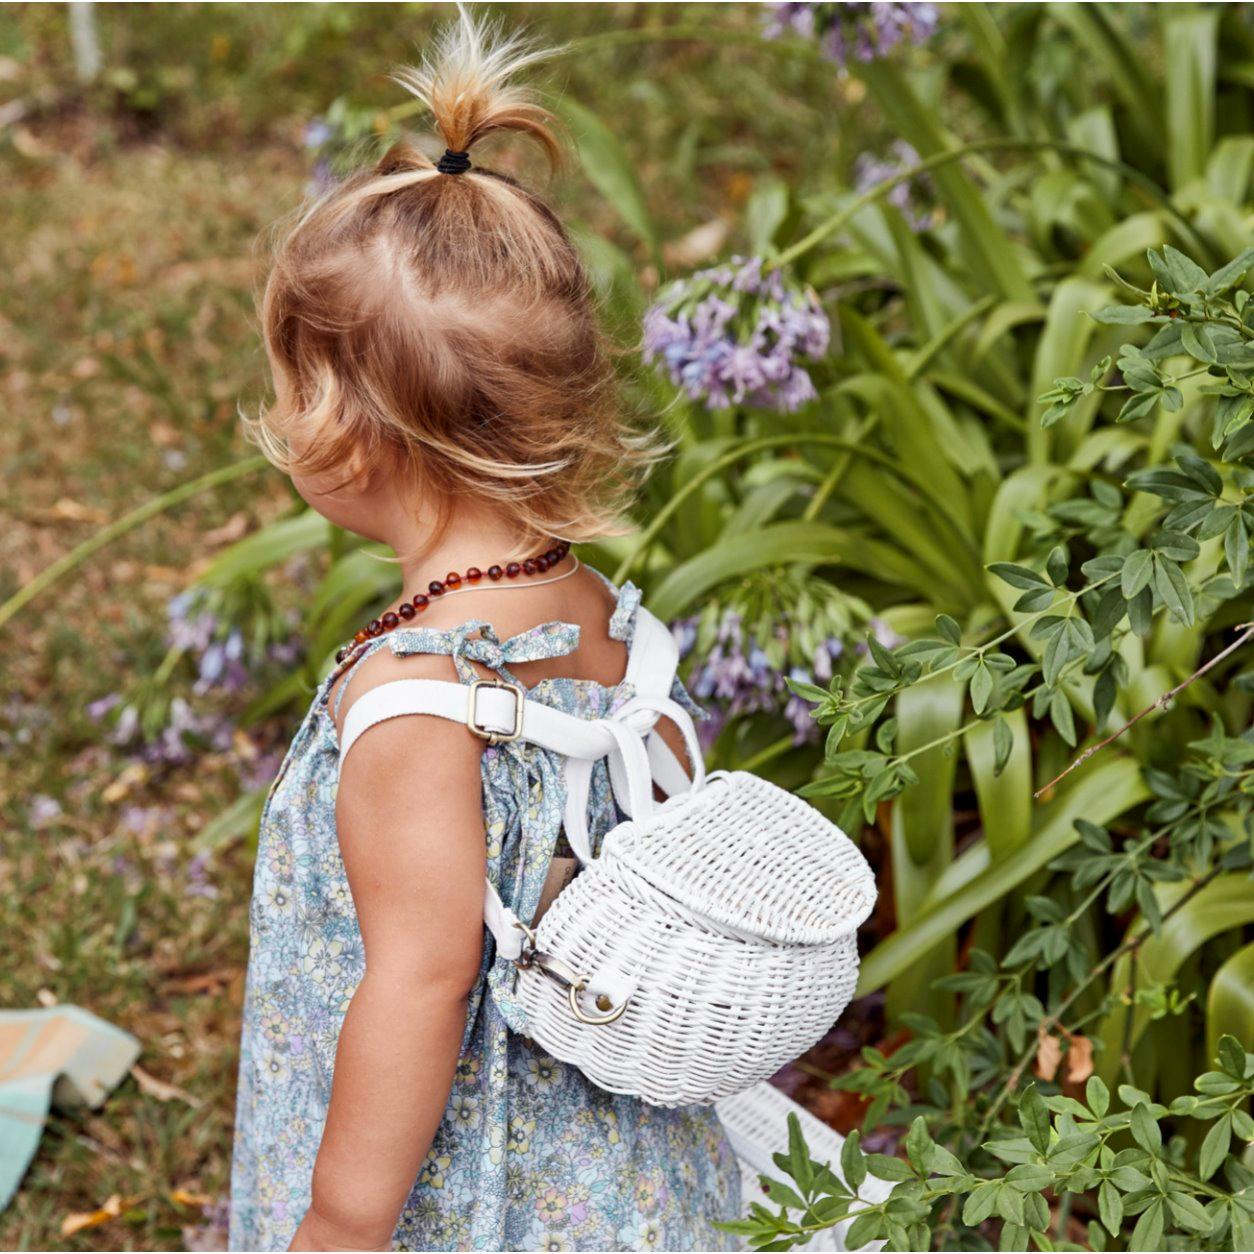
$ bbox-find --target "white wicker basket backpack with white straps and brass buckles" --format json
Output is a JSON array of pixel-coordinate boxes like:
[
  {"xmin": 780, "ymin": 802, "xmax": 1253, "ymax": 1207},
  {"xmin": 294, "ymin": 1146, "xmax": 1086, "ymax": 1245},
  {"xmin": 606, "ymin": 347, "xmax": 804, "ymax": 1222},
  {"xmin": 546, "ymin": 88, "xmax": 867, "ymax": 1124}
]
[{"xmin": 340, "ymin": 608, "xmax": 875, "ymax": 1106}]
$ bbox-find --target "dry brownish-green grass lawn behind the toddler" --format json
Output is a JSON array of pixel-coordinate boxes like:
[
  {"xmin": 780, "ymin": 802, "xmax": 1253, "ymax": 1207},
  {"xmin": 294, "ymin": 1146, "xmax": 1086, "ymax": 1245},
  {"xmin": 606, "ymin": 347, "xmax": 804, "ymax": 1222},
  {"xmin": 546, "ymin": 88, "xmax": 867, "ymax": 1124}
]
[{"xmin": 0, "ymin": 5, "xmax": 867, "ymax": 1249}]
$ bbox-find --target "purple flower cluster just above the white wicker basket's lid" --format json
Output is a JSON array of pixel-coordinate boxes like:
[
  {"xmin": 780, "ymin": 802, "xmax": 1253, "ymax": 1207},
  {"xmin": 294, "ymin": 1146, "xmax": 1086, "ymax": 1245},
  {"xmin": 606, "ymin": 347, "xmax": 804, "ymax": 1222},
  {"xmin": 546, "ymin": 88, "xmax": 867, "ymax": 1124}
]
[{"xmin": 671, "ymin": 611, "xmax": 844, "ymax": 747}]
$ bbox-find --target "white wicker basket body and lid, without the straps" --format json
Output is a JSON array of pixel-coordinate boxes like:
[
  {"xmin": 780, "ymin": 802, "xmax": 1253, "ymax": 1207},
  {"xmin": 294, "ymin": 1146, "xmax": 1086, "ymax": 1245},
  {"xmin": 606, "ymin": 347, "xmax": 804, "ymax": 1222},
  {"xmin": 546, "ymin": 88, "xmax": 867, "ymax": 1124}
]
[{"xmin": 518, "ymin": 775, "xmax": 874, "ymax": 1106}]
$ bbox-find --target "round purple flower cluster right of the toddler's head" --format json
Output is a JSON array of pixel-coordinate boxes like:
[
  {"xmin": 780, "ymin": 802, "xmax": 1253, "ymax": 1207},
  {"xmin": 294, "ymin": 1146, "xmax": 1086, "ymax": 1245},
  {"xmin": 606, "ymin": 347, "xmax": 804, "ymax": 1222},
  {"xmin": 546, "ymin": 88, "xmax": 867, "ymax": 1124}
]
[{"xmin": 643, "ymin": 257, "xmax": 831, "ymax": 413}]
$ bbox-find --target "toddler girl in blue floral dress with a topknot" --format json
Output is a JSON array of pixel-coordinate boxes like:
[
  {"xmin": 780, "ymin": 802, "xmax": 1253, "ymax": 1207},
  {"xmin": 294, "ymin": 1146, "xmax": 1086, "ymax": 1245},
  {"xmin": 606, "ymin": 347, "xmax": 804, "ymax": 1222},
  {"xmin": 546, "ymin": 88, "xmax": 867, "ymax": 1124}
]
[{"xmin": 231, "ymin": 15, "xmax": 739, "ymax": 1250}]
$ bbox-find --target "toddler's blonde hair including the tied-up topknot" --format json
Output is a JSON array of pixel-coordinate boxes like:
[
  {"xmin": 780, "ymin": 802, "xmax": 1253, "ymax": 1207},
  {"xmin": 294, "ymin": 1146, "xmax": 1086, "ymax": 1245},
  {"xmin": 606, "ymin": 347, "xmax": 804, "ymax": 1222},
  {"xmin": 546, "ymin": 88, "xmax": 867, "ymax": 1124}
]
[{"xmin": 247, "ymin": 10, "xmax": 657, "ymax": 540}]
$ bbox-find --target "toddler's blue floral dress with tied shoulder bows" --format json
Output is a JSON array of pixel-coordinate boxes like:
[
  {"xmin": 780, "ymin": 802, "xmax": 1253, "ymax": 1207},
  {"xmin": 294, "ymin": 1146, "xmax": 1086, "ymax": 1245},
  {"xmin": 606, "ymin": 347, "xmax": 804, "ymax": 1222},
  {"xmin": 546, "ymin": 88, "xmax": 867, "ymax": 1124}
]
[{"xmin": 229, "ymin": 583, "xmax": 740, "ymax": 1250}]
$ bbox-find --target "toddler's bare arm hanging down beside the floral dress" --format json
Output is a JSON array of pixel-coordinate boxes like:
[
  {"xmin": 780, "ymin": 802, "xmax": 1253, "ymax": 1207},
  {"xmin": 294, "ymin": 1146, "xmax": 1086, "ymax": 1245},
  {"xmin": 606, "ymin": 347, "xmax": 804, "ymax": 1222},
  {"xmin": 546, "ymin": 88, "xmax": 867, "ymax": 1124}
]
[{"xmin": 291, "ymin": 682, "xmax": 485, "ymax": 1250}]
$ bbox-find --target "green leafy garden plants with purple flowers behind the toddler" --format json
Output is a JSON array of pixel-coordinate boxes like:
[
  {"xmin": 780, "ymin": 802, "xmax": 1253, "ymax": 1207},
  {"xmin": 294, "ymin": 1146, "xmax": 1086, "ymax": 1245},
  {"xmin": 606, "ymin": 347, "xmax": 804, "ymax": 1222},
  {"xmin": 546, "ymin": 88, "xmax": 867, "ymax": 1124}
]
[{"xmin": 73, "ymin": 4, "xmax": 1254, "ymax": 1249}]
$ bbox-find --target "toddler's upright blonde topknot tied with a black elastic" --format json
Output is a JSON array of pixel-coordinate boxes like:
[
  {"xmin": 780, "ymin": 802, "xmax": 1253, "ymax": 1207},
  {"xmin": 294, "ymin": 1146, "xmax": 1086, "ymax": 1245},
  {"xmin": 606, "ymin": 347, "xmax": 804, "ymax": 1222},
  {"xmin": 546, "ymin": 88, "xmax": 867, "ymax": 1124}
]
[{"xmin": 394, "ymin": 5, "xmax": 561, "ymax": 174}]
